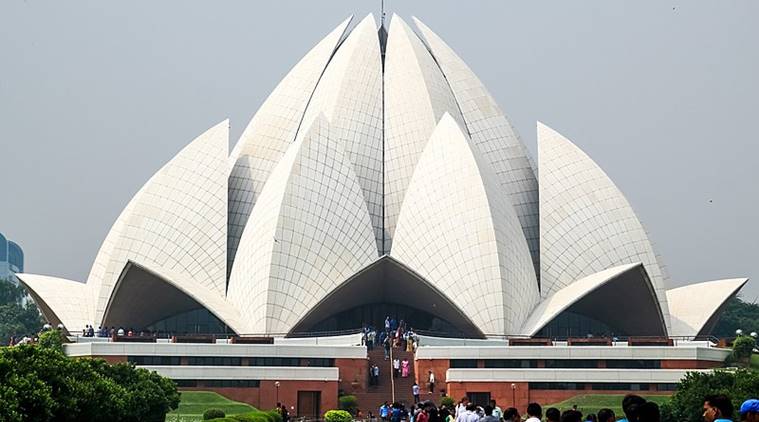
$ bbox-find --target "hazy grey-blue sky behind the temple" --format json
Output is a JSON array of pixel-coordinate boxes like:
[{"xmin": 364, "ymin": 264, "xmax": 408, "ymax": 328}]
[{"xmin": 0, "ymin": 0, "xmax": 759, "ymax": 300}]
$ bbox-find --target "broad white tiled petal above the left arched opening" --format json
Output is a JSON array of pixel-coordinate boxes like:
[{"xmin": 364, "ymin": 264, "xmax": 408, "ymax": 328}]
[{"xmin": 88, "ymin": 121, "xmax": 229, "ymax": 321}]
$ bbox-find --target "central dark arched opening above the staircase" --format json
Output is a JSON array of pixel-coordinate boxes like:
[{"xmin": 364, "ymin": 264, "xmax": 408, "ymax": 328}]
[{"xmin": 288, "ymin": 256, "xmax": 485, "ymax": 338}]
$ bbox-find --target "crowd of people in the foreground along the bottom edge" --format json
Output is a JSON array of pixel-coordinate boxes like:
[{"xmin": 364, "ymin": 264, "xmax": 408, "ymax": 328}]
[{"xmin": 358, "ymin": 396, "xmax": 759, "ymax": 422}]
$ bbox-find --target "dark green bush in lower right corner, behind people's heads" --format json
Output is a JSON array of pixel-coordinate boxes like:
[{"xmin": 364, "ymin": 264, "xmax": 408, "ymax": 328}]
[{"xmin": 661, "ymin": 369, "xmax": 759, "ymax": 422}]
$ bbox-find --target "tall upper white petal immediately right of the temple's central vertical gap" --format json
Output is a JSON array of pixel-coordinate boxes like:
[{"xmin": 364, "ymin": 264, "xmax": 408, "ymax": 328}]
[{"xmin": 384, "ymin": 16, "xmax": 464, "ymax": 253}]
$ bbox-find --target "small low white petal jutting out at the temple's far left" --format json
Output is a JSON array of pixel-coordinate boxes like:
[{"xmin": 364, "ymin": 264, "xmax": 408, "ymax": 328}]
[{"xmin": 16, "ymin": 274, "xmax": 94, "ymax": 334}]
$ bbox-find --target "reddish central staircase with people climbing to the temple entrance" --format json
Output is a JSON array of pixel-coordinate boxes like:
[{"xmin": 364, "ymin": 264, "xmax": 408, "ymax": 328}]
[{"xmin": 356, "ymin": 346, "xmax": 424, "ymax": 416}]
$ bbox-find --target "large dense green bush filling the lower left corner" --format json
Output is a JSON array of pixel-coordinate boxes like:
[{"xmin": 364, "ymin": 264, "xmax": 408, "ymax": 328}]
[{"xmin": 0, "ymin": 342, "xmax": 179, "ymax": 422}]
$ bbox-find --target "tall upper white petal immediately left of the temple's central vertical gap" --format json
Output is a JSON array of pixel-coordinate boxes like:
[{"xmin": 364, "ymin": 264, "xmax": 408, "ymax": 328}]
[{"xmin": 303, "ymin": 14, "xmax": 383, "ymax": 254}]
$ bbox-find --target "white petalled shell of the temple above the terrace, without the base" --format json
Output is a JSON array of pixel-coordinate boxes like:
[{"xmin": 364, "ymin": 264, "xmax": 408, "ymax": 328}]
[{"xmin": 19, "ymin": 15, "xmax": 747, "ymax": 339}]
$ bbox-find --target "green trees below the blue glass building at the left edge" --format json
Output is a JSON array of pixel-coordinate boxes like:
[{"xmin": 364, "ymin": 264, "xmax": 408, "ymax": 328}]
[{"xmin": 0, "ymin": 279, "xmax": 44, "ymax": 344}]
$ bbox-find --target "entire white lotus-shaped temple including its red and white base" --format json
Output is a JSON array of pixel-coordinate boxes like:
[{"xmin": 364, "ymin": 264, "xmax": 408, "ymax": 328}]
[{"xmin": 18, "ymin": 15, "xmax": 747, "ymax": 415}]
